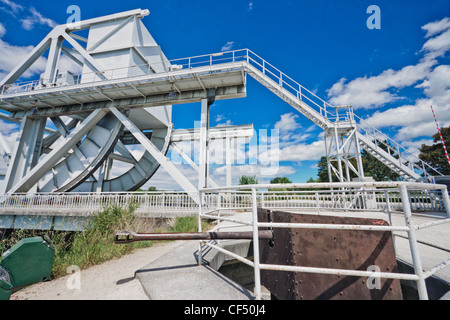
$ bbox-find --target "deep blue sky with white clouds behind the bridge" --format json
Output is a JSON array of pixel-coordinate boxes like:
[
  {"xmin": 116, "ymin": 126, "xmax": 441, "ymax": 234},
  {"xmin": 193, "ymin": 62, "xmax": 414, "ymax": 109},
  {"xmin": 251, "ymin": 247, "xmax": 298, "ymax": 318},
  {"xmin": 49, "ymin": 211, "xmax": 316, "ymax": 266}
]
[{"xmin": 0, "ymin": 0, "xmax": 450, "ymax": 188}]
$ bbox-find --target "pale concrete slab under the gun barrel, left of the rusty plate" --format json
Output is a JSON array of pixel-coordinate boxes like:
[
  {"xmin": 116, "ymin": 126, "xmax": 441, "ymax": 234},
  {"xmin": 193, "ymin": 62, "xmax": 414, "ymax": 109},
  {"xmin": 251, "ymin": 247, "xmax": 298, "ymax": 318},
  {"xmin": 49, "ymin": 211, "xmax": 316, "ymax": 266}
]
[{"xmin": 136, "ymin": 241, "xmax": 254, "ymax": 300}]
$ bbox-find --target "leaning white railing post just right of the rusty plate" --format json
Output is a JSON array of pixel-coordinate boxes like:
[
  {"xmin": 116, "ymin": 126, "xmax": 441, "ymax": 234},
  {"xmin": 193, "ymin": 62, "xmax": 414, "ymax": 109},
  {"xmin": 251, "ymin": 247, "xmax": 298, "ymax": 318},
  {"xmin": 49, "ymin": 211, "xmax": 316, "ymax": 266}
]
[{"xmin": 400, "ymin": 185, "xmax": 428, "ymax": 300}]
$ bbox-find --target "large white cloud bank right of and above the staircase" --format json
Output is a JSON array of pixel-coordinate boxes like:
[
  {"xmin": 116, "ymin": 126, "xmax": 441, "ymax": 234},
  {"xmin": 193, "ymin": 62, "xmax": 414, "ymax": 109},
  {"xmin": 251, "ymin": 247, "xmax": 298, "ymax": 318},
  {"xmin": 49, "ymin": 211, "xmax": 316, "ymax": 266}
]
[{"xmin": 328, "ymin": 18, "xmax": 450, "ymax": 154}]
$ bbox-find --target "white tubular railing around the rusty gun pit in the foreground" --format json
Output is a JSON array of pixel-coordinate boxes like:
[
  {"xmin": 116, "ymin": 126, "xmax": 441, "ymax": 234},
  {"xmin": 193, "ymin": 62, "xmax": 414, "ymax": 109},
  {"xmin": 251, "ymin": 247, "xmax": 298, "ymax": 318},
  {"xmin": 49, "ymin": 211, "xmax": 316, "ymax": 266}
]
[{"xmin": 198, "ymin": 182, "xmax": 450, "ymax": 300}]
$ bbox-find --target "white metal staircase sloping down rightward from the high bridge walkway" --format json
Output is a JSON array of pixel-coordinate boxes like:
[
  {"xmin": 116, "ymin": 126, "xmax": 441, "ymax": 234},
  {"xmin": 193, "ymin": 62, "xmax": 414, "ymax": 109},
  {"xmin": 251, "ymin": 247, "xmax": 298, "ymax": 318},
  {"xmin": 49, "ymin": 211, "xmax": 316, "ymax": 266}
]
[{"xmin": 239, "ymin": 50, "xmax": 442, "ymax": 181}]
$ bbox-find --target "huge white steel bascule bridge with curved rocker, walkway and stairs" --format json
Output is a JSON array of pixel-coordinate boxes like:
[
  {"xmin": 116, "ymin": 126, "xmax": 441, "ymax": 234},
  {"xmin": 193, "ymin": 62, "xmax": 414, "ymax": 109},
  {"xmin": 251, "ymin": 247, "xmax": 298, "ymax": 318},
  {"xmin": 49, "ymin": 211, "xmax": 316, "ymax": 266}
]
[{"xmin": 0, "ymin": 9, "xmax": 442, "ymax": 228}]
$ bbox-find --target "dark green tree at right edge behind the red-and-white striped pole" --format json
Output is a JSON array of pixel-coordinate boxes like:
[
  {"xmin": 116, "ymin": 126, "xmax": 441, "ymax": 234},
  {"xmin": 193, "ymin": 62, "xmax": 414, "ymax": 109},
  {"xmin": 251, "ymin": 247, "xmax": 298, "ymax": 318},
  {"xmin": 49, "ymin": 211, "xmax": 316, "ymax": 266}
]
[{"xmin": 419, "ymin": 126, "xmax": 450, "ymax": 175}]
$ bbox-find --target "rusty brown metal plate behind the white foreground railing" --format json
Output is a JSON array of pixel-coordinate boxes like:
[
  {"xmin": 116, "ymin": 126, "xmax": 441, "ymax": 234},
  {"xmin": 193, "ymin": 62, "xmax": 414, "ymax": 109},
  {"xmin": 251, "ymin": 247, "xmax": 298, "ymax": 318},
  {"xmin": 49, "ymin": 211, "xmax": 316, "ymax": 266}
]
[{"xmin": 258, "ymin": 209, "xmax": 402, "ymax": 300}]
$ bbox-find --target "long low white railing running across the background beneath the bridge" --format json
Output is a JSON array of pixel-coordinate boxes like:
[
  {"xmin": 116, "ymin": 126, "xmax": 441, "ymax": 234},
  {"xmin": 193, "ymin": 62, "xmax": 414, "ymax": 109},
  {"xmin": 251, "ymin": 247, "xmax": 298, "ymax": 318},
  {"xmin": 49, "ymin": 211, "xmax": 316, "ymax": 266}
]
[{"xmin": 0, "ymin": 184, "xmax": 445, "ymax": 216}]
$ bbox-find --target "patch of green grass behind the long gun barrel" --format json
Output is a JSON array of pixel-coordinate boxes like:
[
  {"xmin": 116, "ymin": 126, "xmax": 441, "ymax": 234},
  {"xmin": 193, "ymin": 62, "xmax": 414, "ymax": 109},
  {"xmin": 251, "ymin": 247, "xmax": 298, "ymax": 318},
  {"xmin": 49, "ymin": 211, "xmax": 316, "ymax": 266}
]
[{"xmin": 0, "ymin": 206, "xmax": 209, "ymax": 278}]
